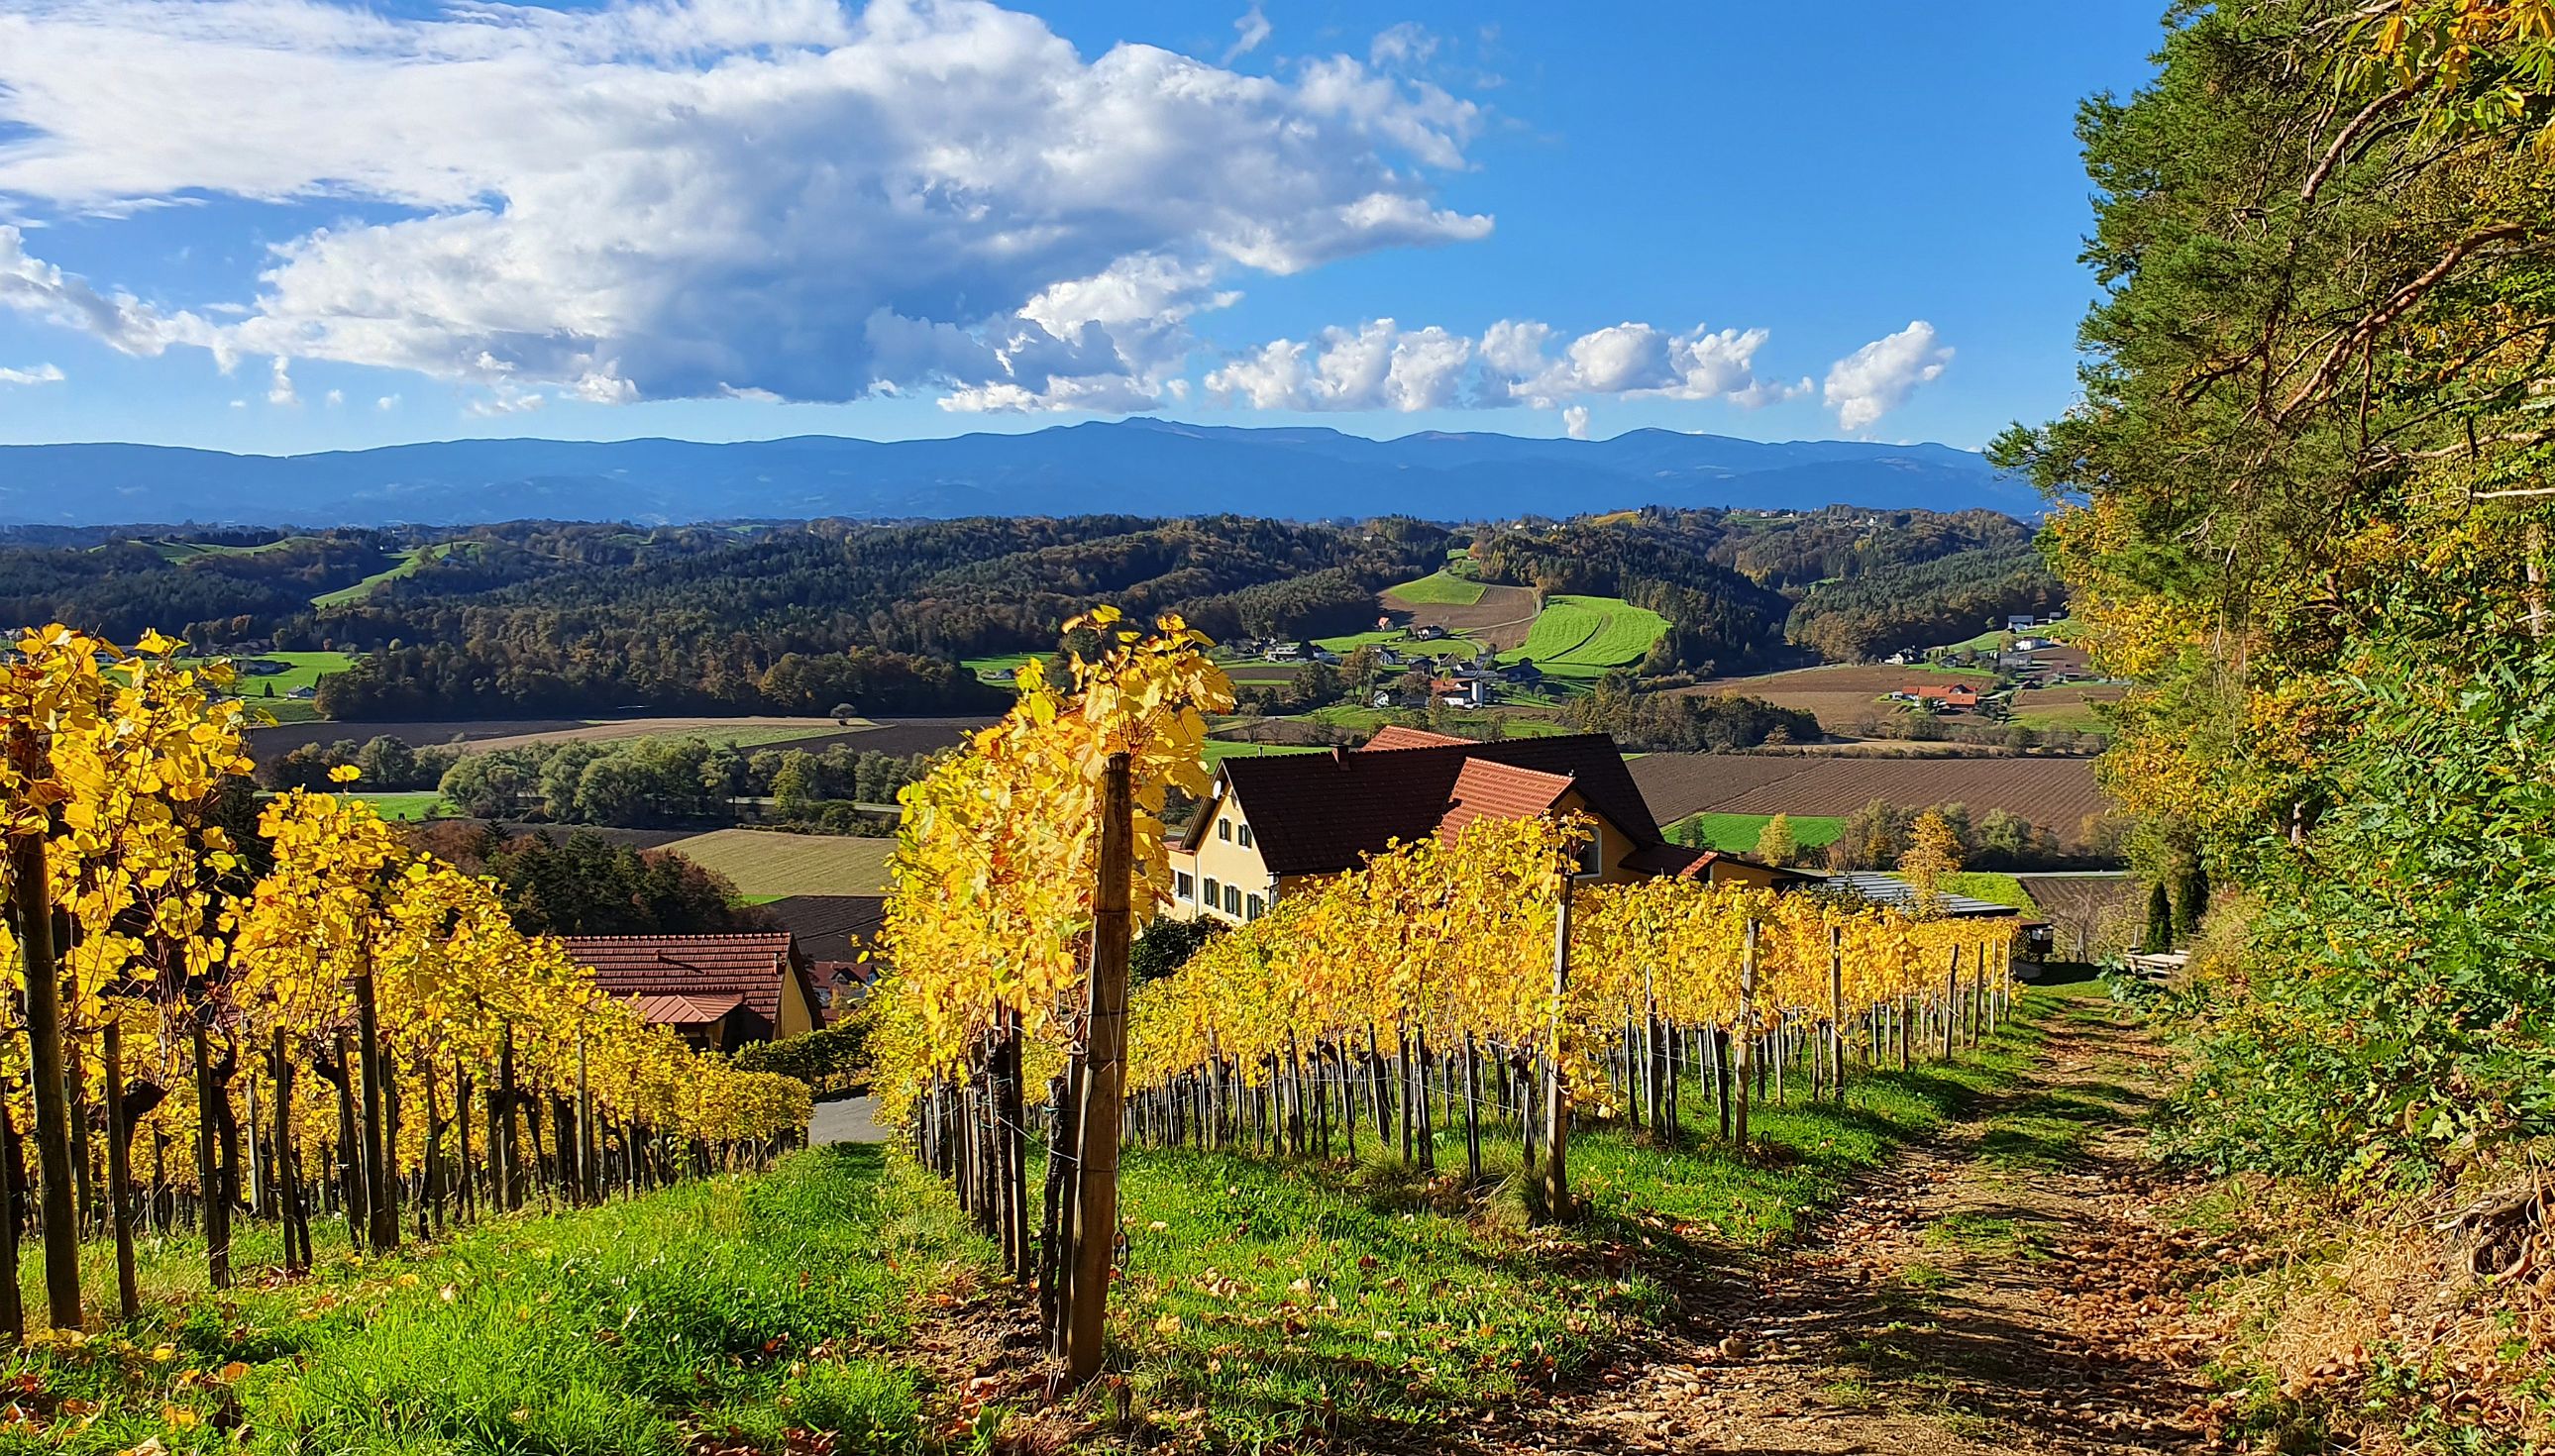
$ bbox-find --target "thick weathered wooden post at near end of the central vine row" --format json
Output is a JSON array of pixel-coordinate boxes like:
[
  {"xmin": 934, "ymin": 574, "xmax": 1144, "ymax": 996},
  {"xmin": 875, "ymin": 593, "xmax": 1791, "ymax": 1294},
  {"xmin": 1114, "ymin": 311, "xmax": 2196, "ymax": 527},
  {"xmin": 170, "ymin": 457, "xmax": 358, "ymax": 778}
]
[{"xmin": 1065, "ymin": 754, "xmax": 1134, "ymax": 1385}]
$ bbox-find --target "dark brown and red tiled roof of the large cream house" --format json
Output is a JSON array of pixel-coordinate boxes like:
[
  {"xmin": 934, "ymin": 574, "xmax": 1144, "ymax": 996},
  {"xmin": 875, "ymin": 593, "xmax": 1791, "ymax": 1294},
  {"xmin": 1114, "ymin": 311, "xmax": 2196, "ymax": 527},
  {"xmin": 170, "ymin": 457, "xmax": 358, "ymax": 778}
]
[{"xmin": 1183, "ymin": 728, "xmax": 1658, "ymax": 874}]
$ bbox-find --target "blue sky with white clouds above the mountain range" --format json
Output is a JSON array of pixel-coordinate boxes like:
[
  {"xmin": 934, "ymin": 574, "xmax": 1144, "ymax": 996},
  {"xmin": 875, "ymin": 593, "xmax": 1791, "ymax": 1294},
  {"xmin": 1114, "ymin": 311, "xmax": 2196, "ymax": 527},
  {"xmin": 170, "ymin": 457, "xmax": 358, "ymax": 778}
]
[{"xmin": 0, "ymin": 0, "xmax": 2159, "ymax": 452}]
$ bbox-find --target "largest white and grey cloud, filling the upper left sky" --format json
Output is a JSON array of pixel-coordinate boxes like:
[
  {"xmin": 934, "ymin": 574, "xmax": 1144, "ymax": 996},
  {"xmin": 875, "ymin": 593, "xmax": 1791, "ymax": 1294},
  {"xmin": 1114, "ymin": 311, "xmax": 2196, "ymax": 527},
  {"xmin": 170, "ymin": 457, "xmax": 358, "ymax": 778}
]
[{"xmin": 0, "ymin": 0, "xmax": 1492, "ymax": 411}]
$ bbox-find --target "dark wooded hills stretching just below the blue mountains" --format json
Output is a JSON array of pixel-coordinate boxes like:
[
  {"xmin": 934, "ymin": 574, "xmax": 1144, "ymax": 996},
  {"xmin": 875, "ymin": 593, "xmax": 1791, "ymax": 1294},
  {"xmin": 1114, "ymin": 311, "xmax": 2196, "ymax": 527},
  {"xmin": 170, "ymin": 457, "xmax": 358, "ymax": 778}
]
[{"xmin": 0, "ymin": 506, "xmax": 2057, "ymax": 715}]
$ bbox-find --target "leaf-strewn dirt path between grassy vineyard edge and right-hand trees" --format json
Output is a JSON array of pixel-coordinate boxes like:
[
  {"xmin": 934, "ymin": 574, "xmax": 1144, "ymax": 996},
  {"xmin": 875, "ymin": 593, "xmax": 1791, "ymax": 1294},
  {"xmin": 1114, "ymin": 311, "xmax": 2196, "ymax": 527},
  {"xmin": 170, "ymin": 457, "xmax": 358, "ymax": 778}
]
[{"xmin": 1479, "ymin": 1001, "xmax": 2205, "ymax": 1456}]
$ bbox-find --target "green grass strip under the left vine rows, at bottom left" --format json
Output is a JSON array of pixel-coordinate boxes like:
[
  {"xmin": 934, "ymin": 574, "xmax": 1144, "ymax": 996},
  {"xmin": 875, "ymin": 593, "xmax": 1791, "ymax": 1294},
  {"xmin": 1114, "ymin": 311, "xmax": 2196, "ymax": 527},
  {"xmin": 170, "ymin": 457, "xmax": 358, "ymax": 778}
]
[{"xmin": 0, "ymin": 1147, "xmax": 986, "ymax": 1456}]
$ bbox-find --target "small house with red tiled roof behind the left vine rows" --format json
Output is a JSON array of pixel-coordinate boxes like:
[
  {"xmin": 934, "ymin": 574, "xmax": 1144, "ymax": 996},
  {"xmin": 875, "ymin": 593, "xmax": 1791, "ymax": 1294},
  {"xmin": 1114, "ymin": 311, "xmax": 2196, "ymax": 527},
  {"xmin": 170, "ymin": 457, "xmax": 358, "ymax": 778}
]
[{"xmin": 560, "ymin": 930, "xmax": 822, "ymax": 1053}]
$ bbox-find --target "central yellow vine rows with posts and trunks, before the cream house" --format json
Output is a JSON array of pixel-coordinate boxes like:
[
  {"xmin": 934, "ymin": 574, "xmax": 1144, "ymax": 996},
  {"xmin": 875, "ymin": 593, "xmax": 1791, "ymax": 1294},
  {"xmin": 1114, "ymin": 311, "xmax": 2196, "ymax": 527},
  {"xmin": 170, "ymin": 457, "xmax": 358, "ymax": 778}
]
[{"xmin": 871, "ymin": 613, "xmax": 2013, "ymax": 1380}]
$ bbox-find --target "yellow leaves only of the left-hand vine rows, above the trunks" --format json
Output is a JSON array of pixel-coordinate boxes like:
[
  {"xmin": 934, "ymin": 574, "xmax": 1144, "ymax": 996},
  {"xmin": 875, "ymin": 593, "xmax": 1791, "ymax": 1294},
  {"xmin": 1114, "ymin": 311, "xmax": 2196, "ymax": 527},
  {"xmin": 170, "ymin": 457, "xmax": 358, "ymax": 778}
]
[{"xmin": 0, "ymin": 626, "xmax": 807, "ymax": 1183}]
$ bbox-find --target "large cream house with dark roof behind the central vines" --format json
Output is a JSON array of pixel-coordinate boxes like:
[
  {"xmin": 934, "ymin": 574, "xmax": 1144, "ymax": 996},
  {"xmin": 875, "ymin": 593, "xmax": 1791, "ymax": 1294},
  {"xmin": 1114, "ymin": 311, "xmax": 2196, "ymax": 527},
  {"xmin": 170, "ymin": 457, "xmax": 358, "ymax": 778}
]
[{"xmin": 1170, "ymin": 728, "xmax": 1814, "ymax": 922}]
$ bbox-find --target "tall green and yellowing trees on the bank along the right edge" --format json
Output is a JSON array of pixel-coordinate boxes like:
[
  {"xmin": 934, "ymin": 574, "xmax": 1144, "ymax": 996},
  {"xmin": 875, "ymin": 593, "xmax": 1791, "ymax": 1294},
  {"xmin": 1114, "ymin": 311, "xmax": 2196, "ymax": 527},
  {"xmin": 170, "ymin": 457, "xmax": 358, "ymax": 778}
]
[{"xmin": 1993, "ymin": 0, "xmax": 2555, "ymax": 1451}]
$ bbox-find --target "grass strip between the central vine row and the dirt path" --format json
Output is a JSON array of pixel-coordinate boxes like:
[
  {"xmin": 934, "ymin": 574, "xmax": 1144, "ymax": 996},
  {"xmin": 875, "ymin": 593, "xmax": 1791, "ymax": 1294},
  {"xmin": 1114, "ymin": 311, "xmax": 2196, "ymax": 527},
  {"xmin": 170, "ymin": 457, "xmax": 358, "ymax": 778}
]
[{"xmin": 1112, "ymin": 991, "xmax": 2067, "ymax": 1451}]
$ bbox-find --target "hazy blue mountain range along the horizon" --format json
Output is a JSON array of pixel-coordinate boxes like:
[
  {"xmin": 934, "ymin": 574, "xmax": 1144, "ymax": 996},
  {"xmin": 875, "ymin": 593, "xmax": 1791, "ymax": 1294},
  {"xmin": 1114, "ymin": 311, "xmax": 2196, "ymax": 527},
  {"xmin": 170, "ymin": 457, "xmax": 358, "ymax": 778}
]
[{"xmin": 0, "ymin": 419, "xmax": 2042, "ymax": 526}]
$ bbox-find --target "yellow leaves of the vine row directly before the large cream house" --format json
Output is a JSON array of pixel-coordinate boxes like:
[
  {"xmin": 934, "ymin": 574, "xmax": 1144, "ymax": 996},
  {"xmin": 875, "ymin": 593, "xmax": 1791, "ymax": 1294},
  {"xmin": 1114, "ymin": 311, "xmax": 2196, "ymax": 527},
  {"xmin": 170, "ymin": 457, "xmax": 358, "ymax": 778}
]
[{"xmin": 1129, "ymin": 817, "xmax": 2013, "ymax": 1098}]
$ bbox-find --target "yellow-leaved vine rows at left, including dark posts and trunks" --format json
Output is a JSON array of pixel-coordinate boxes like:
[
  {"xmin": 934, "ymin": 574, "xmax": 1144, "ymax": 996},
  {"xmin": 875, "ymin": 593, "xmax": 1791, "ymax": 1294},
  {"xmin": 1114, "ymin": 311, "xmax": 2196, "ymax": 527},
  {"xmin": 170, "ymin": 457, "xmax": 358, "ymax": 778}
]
[{"xmin": 0, "ymin": 626, "xmax": 807, "ymax": 1338}]
